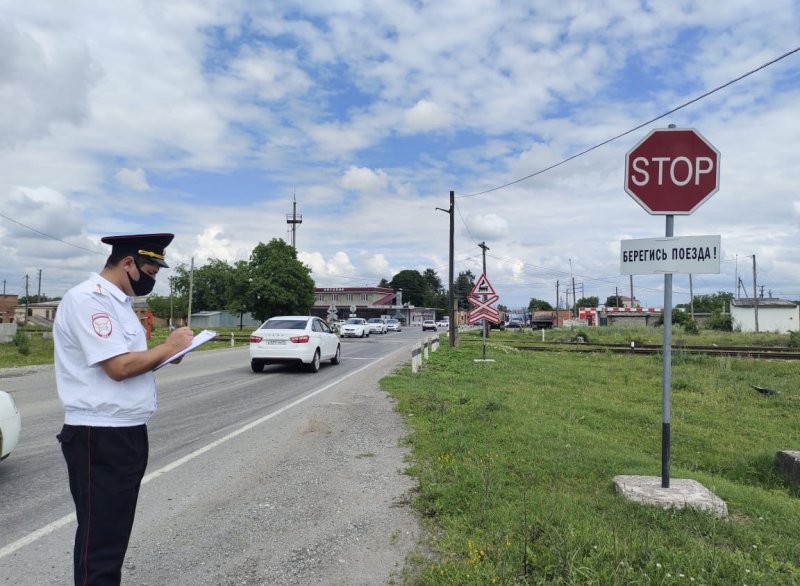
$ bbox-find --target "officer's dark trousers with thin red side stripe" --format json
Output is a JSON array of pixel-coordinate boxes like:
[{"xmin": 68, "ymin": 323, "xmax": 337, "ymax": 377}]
[{"xmin": 58, "ymin": 425, "xmax": 149, "ymax": 586}]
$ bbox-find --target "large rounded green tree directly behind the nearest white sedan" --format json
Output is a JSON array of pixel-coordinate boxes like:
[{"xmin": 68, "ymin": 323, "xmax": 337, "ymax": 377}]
[{"xmin": 247, "ymin": 238, "xmax": 314, "ymax": 321}]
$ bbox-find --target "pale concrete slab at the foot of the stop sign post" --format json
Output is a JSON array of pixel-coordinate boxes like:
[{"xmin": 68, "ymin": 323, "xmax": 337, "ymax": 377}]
[{"xmin": 614, "ymin": 476, "xmax": 728, "ymax": 517}]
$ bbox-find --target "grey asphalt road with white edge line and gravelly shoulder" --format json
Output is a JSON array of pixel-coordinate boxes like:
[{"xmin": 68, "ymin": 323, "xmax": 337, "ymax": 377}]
[{"xmin": 0, "ymin": 329, "xmax": 434, "ymax": 586}]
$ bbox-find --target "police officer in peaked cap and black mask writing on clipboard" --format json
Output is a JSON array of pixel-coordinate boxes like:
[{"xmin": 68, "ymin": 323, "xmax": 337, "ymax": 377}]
[{"xmin": 53, "ymin": 234, "xmax": 192, "ymax": 586}]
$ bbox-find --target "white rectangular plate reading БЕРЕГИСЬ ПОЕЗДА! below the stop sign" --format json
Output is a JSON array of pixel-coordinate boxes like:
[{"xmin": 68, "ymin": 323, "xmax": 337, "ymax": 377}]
[{"xmin": 620, "ymin": 236, "xmax": 722, "ymax": 275}]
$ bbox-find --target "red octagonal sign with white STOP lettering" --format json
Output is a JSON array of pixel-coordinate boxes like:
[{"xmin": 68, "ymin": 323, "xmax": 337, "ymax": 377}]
[{"xmin": 625, "ymin": 128, "xmax": 720, "ymax": 215}]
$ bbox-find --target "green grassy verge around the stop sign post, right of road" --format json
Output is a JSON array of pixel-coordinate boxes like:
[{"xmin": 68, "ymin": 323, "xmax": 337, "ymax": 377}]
[{"xmin": 382, "ymin": 334, "xmax": 800, "ymax": 585}]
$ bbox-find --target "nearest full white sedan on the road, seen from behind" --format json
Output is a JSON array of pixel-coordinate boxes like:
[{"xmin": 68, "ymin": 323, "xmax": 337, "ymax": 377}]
[{"xmin": 250, "ymin": 315, "xmax": 341, "ymax": 372}]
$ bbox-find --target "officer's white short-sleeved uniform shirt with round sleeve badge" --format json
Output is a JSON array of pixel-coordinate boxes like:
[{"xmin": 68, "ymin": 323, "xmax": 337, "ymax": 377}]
[{"xmin": 53, "ymin": 273, "xmax": 156, "ymax": 427}]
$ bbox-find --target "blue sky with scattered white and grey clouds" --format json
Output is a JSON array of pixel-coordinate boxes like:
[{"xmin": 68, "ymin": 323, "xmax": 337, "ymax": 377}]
[{"xmin": 0, "ymin": 0, "xmax": 800, "ymax": 307}]
